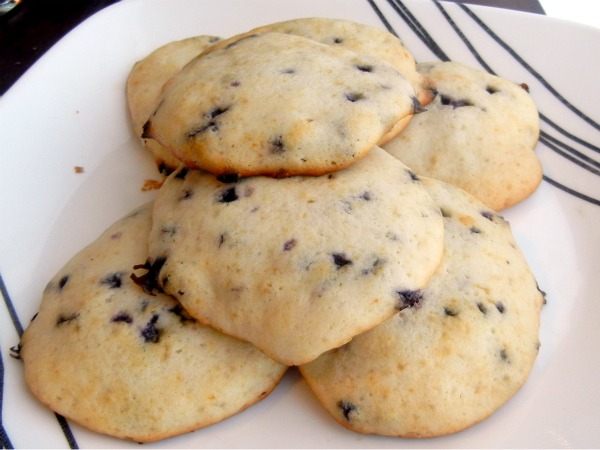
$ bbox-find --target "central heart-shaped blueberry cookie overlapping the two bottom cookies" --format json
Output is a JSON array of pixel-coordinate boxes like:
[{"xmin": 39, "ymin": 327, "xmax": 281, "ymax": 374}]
[{"xmin": 148, "ymin": 148, "xmax": 443, "ymax": 365}]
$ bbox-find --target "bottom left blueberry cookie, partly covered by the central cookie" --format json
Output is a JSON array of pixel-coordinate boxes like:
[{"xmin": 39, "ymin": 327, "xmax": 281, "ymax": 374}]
[{"xmin": 20, "ymin": 205, "xmax": 286, "ymax": 442}]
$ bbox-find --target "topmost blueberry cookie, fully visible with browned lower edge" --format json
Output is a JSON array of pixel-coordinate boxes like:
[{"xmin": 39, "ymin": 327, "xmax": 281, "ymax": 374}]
[{"xmin": 144, "ymin": 33, "xmax": 415, "ymax": 177}]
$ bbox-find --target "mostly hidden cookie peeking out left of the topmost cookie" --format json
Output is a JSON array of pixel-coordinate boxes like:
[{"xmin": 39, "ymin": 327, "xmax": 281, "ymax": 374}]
[{"xmin": 126, "ymin": 36, "xmax": 219, "ymax": 175}]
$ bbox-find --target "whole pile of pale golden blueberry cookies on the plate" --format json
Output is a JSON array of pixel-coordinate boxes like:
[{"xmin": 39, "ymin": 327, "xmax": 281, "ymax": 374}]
[{"xmin": 21, "ymin": 18, "xmax": 543, "ymax": 442}]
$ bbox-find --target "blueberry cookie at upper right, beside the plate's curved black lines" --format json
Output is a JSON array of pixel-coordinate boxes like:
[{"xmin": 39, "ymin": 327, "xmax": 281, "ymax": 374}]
[{"xmin": 384, "ymin": 62, "xmax": 542, "ymax": 210}]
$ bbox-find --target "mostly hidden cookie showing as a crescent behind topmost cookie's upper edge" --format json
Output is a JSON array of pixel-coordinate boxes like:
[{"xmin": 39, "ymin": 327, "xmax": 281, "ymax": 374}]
[{"xmin": 207, "ymin": 17, "xmax": 433, "ymax": 112}]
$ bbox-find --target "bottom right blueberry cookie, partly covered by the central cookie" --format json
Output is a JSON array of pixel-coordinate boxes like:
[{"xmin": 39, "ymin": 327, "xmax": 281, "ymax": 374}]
[{"xmin": 300, "ymin": 178, "xmax": 544, "ymax": 438}]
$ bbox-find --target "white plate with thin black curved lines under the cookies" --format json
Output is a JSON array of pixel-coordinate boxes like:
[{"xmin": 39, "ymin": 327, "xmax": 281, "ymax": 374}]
[{"xmin": 0, "ymin": 0, "xmax": 600, "ymax": 448}]
